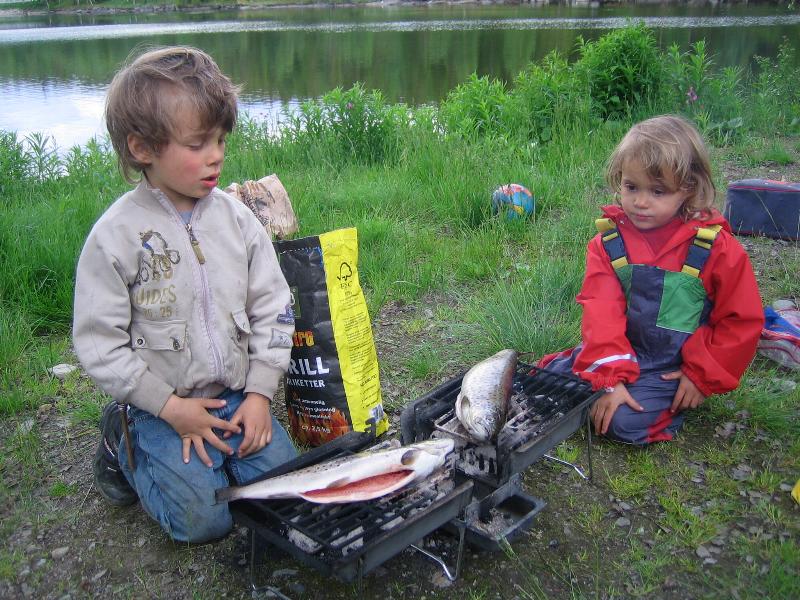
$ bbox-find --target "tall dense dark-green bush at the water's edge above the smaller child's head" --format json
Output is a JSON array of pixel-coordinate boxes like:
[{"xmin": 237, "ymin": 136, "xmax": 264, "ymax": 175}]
[{"xmin": 577, "ymin": 23, "xmax": 664, "ymax": 118}]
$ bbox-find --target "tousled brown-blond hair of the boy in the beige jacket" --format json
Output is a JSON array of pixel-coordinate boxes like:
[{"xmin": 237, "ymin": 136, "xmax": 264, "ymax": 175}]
[{"xmin": 105, "ymin": 46, "xmax": 239, "ymax": 183}]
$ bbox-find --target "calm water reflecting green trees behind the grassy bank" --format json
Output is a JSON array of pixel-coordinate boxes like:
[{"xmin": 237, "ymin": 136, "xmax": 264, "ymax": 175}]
[{"xmin": 0, "ymin": 4, "xmax": 800, "ymax": 150}]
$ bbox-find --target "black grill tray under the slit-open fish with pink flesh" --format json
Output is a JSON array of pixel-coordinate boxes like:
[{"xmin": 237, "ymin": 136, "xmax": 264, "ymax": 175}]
[{"xmin": 231, "ymin": 432, "xmax": 473, "ymax": 582}]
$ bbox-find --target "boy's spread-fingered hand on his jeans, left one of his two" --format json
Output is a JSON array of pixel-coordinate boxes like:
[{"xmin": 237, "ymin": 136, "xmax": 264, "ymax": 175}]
[{"xmin": 158, "ymin": 394, "xmax": 240, "ymax": 467}]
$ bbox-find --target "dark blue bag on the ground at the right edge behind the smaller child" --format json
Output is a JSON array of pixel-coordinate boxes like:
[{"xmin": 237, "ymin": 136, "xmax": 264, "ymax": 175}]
[{"xmin": 723, "ymin": 179, "xmax": 800, "ymax": 240}]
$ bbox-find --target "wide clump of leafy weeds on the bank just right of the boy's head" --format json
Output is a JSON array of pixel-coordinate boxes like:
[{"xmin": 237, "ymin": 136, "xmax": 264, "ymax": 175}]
[{"xmin": 286, "ymin": 83, "xmax": 408, "ymax": 164}]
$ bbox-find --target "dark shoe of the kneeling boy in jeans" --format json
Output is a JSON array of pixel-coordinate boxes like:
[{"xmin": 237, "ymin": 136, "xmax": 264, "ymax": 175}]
[{"xmin": 92, "ymin": 400, "xmax": 139, "ymax": 506}]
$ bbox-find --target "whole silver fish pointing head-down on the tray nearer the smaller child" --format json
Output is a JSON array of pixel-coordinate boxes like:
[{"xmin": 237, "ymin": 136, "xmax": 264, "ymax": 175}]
[{"xmin": 455, "ymin": 350, "xmax": 517, "ymax": 443}]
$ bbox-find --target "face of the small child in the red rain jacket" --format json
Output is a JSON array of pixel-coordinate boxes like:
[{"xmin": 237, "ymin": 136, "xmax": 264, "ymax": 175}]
[{"xmin": 620, "ymin": 160, "xmax": 690, "ymax": 229}]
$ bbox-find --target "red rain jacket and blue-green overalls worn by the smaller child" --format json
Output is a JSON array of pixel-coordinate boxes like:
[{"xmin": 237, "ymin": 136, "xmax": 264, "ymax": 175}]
[{"xmin": 539, "ymin": 206, "xmax": 764, "ymax": 444}]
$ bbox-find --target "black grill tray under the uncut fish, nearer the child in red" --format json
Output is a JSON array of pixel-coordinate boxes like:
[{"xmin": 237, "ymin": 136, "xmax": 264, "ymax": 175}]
[{"xmin": 400, "ymin": 363, "xmax": 600, "ymax": 488}]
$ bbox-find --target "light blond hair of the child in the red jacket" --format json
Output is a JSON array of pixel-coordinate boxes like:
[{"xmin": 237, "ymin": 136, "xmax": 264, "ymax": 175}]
[{"xmin": 606, "ymin": 115, "xmax": 716, "ymax": 221}]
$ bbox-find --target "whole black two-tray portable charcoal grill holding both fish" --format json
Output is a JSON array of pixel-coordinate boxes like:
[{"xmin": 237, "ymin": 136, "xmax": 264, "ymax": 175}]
[{"xmin": 231, "ymin": 364, "xmax": 599, "ymax": 588}]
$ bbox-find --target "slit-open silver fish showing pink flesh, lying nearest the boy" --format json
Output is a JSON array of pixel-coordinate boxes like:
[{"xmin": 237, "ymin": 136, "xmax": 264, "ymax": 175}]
[{"xmin": 216, "ymin": 438, "xmax": 454, "ymax": 504}]
